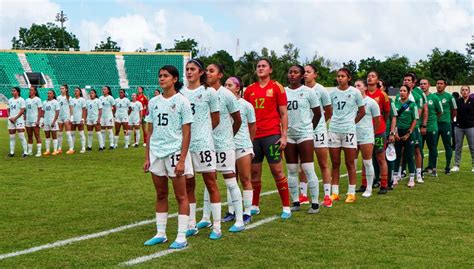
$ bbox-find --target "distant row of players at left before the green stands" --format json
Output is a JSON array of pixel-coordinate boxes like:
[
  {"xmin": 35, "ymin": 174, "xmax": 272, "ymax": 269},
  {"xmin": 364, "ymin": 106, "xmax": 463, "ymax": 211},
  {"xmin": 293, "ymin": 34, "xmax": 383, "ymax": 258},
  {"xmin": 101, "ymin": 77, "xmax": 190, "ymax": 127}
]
[{"xmin": 8, "ymin": 85, "xmax": 154, "ymax": 157}]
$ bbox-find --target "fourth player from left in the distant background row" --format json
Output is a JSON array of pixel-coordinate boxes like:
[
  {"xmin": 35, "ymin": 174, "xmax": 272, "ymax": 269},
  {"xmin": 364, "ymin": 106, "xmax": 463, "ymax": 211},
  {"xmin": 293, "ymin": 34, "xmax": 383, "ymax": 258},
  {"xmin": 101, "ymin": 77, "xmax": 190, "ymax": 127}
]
[{"xmin": 56, "ymin": 84, "xmax": 74, "ymax": 154}]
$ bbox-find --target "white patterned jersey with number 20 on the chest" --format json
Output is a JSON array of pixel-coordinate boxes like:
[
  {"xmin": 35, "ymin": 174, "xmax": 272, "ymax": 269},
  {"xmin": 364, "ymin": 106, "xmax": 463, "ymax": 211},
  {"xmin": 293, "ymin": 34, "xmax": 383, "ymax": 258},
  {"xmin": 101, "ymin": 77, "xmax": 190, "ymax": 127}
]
[{"xmin": 285, "ymin": 85, "xmax": 320, "ymax": 140}]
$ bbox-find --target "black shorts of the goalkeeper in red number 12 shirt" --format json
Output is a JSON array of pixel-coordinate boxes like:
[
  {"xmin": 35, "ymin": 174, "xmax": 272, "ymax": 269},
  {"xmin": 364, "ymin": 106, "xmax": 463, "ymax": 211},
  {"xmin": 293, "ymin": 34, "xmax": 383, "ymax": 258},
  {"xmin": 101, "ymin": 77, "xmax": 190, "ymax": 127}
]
[{"xmin": 252, "ymin": 135, "xmax": 281, "ymax": 163}]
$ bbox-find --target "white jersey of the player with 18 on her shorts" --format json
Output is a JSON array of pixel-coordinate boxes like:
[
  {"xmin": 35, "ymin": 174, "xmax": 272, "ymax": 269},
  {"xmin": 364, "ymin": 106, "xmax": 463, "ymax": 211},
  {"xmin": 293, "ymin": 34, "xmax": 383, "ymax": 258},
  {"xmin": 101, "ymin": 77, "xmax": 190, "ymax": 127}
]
[{"xmin": 181, "ymin": 86, "xmax": 220, "ymax": 152}]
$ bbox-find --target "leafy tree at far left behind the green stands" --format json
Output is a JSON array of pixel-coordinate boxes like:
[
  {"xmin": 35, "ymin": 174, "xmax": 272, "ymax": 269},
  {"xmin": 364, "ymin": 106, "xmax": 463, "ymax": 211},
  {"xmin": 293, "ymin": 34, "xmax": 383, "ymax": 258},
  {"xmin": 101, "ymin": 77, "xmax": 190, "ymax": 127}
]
[{"xmin": 12, "ymin": 22, "xmax": 79, "ymax": 49}]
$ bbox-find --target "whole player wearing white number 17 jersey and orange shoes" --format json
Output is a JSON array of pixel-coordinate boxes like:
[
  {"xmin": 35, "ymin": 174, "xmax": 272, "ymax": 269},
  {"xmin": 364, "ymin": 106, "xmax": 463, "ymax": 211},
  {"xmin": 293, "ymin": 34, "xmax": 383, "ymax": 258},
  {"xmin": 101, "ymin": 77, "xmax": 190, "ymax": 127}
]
[{"xmin": 328, "ymin": 68, "xmax": 365, "ymax": 203}]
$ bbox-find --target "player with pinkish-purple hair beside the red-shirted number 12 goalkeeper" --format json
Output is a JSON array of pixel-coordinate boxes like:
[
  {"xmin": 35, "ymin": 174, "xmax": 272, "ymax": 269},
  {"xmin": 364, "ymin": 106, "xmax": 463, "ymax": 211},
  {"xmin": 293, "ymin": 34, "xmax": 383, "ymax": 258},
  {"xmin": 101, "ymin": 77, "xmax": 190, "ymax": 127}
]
[{"xmin": 225, "ymin": 77, "xmax": 257, "ymax": 224}]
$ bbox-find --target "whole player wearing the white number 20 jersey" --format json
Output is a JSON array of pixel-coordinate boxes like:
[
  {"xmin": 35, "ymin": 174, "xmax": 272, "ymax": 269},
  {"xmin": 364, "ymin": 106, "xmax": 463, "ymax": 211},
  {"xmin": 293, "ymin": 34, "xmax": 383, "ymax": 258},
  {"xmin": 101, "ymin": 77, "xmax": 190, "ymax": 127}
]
[{"xmin": 285, "ymin": 65, "xmax": 321, "ymax": 214}]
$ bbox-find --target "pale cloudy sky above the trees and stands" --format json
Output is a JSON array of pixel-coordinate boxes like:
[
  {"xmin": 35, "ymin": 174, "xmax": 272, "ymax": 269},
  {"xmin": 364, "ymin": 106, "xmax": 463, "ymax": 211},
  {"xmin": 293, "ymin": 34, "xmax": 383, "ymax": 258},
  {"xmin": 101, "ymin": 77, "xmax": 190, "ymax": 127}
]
[{"xmin": 0, "ymin": 0, "xmax": 474, "ymax": 63}]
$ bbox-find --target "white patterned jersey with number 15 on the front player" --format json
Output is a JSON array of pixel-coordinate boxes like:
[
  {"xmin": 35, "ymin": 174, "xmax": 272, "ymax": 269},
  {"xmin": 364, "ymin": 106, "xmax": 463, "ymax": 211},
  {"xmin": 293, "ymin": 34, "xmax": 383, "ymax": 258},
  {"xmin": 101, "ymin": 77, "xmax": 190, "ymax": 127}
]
[{"xmin": 145, "ymin": 93, "xmax": 193, "ymax": 158}]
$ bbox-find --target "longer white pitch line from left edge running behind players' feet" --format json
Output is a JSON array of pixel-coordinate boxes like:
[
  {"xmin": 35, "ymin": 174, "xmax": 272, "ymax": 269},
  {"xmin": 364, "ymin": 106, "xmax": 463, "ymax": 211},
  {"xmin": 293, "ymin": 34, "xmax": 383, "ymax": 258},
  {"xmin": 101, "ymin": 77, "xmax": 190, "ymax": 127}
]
[{"xmin": 0, "ymin": 171, "xmax": 360, "ymax": 260}]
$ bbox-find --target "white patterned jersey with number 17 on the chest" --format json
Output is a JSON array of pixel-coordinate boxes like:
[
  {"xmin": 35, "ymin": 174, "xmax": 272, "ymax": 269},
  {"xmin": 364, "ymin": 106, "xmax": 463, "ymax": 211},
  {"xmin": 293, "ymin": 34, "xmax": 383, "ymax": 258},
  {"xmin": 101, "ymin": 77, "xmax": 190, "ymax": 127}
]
[{"xmin": 329, "ymin": 86, "xmax": 364, "ymax": 134}]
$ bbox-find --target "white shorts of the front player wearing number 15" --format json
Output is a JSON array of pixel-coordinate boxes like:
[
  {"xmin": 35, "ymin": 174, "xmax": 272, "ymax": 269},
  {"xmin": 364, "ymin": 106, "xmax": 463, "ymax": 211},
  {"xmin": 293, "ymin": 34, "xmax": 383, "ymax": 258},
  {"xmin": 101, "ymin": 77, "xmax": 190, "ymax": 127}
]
[{"xmin": 149, "ymin": 151, "xmax": 194, "ymax": 177}]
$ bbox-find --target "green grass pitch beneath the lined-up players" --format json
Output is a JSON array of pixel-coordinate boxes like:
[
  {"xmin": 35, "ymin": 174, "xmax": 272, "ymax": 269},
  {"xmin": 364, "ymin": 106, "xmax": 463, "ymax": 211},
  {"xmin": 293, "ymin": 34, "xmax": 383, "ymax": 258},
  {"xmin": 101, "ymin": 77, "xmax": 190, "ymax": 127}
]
[{"xmin": 0, "ymin": 120, "xmax": 474, "ymax": 268}]
